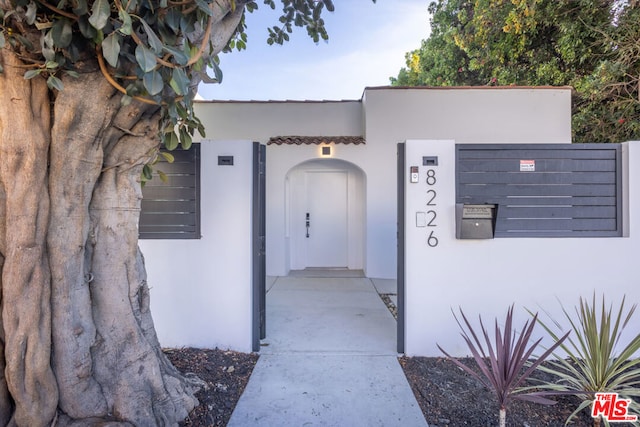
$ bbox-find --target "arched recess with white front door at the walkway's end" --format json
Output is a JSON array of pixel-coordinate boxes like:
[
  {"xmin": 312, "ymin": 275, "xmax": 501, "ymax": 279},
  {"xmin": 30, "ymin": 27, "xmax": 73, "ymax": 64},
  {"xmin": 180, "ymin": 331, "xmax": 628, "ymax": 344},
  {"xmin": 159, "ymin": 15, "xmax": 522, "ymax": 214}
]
[{"xmin": 285, "ymin": 159, "xmax": 366, "ymax": 270}]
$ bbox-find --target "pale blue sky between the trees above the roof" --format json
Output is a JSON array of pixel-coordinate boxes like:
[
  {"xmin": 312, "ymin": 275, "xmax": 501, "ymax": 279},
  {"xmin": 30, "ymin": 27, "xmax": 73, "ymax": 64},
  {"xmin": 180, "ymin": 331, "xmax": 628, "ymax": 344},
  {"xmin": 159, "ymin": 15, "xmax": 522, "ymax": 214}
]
[{"xmin": 199, "ymin": 0, "xmax": 430, "ymax": 101}]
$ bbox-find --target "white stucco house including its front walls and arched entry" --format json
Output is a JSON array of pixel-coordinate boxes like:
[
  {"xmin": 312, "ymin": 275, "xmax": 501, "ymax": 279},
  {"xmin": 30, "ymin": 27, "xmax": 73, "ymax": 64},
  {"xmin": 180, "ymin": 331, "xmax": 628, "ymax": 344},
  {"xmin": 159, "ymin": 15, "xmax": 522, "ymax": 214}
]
[{"xmin": 140, "ymin": 87, "xmax": 640, "ymax": 355}]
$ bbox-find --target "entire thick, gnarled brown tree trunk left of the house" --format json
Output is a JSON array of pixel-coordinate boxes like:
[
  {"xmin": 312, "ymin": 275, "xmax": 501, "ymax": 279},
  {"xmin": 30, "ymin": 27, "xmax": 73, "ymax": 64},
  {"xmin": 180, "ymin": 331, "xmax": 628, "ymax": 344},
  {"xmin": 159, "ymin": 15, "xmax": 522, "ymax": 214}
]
[{"xmin": 0, "ymin": 50, "xmax": 197, "ymax": 427}]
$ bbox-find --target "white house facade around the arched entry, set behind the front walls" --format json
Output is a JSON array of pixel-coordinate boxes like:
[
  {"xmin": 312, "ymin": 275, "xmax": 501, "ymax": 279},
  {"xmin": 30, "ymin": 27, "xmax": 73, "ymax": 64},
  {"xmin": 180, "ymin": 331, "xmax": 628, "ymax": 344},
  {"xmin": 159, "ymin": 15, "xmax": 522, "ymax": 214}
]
[{"xmin": 197, "ymin": 88, "xmax": 571, "ymax": 278}]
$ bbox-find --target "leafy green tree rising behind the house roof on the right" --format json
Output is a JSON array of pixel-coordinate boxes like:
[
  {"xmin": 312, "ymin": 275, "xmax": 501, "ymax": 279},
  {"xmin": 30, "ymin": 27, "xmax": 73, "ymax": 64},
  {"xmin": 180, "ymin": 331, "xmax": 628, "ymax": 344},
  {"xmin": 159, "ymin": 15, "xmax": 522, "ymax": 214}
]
[{"xmin": 391, "ymin": 0, "xmax": 640, "ymax": 142}]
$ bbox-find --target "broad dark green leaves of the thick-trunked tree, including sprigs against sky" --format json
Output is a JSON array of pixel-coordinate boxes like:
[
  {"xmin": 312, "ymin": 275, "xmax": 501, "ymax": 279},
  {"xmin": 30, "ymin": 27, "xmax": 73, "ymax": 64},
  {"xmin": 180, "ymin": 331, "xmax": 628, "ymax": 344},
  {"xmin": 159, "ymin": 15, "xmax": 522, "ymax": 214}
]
[{"xmin": 0, "ymin": 0, "xmax": 350, "ymax": 149}]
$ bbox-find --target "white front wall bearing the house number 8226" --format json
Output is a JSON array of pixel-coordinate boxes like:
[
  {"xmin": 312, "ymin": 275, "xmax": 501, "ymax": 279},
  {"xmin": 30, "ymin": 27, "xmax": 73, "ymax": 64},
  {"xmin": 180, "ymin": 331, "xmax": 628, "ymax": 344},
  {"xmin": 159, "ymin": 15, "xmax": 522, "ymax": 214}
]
[{"xmin": 405, "ymin": 141, "xmax": 640, "ymax": 356}]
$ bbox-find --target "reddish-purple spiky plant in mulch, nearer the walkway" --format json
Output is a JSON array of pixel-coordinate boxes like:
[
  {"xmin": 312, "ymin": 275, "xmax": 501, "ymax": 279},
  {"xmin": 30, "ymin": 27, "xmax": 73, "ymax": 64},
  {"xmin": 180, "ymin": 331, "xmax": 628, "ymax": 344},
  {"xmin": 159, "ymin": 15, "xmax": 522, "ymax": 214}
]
[{"xmin": 438, "ymin": 305, "xmax": 569, "ymax": 427}]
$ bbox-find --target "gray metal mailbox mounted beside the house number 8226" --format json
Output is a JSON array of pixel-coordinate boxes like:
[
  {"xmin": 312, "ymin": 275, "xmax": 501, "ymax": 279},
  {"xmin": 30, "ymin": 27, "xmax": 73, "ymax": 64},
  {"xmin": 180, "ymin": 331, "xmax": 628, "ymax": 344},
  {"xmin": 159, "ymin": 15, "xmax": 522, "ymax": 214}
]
[{"xmin": 456, "ymin": 203, "xmax": 498, "ymax": 239}]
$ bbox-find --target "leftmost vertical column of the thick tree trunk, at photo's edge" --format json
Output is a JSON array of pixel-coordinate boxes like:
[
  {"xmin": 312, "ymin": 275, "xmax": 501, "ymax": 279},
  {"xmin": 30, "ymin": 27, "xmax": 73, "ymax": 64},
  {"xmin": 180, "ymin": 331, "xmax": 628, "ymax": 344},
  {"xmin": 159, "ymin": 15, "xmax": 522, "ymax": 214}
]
[{"xmin": 0, "ymin": 47, "xmax": 57, "ymax": 426}]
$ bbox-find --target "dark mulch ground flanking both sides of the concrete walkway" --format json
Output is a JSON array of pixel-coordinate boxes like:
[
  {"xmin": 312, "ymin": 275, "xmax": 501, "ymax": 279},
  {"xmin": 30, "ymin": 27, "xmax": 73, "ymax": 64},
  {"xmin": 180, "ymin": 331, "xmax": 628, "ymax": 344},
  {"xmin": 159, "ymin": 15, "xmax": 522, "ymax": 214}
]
[{"xmin": 165, "ymin": 348, "xmax": 631, "ymax": 427}]
